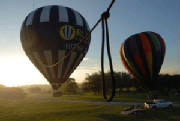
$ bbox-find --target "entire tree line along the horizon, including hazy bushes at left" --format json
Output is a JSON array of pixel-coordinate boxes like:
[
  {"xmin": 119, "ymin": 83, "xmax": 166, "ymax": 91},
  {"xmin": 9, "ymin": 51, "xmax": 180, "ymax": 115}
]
[{"xmin": 0, "ymin": 72, "xmax": 180, "ymax": 98}]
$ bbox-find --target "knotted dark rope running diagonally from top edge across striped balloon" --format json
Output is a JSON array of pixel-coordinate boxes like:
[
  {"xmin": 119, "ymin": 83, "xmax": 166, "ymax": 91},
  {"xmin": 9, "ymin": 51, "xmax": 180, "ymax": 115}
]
[{"xmin": 42, "ymin": 0, "xmax": 115, "ymax": 68}]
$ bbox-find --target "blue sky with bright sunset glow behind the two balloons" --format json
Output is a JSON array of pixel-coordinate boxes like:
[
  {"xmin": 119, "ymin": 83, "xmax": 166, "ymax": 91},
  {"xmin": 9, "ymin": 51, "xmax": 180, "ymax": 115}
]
[{"xmin": 0, "ymin": 0, "xmax": 180, "ymax": 86}]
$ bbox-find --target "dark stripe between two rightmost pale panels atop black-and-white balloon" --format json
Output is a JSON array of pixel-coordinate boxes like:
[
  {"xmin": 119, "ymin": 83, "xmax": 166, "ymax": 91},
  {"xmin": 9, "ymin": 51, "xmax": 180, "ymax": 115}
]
[{"xmin": 66, "ymin": 7, "xmax": 76, "ymax": 25}]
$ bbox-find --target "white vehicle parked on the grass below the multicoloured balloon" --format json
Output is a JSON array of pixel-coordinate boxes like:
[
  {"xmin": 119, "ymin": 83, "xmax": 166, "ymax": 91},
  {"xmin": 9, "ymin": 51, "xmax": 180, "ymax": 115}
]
[{"xmin": 144, "ymin": 99, "xmax": 173, "ymax": 109}]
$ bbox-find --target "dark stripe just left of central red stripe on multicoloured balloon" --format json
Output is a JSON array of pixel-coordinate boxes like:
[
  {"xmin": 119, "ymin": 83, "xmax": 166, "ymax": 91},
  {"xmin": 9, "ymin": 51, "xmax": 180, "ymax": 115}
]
[{"xmin": 136, "ymin": 34, "xmax": 150, "ymax": 80}]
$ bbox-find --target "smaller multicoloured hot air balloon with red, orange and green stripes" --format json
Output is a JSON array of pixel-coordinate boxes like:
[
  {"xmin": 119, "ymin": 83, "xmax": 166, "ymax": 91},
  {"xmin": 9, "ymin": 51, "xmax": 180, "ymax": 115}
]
[{"xmin": 120, "ymin": 31, "xmax": 165, "ymax": 89}]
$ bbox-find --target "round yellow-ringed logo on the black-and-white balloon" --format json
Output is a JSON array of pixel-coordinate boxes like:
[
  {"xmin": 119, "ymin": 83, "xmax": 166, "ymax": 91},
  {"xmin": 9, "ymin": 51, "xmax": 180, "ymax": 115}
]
[{"xmin": 59, "ymin": 25, "xmax": 76, "ymax": 40}]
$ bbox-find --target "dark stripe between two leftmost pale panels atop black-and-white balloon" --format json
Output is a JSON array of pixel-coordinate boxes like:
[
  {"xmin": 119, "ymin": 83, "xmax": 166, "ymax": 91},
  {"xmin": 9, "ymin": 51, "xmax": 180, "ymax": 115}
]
[{"xmin": 32, "ymin": 7, "xmax": 44, "ymax": 29}]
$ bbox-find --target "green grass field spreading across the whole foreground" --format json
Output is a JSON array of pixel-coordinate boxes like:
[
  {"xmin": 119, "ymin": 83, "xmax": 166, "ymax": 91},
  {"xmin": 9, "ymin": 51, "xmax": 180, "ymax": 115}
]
[{"xmin": 0, "ymin": 93, "xmax": 179, "ymax": 121}]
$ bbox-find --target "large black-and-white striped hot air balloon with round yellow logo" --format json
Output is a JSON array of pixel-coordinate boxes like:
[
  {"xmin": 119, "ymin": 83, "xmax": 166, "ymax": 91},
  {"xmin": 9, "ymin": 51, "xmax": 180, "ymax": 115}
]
[{"xmin": 20, "ymin": 5, "xmax": 90, "ymax": 90}]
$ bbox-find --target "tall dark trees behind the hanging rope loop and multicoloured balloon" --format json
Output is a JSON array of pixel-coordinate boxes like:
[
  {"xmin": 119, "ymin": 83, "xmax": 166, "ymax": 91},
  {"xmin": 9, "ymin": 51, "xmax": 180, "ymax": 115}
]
[{"xmin": 82, "ymin": 72, "xmax": 180, "ymax": 93}]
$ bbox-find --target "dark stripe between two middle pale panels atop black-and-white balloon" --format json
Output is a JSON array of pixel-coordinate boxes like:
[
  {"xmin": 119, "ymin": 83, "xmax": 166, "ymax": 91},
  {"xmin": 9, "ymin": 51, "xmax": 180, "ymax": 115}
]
[{"xmin": 49, "ymin": 6, "xmax": 59, "ymax": 24}]
